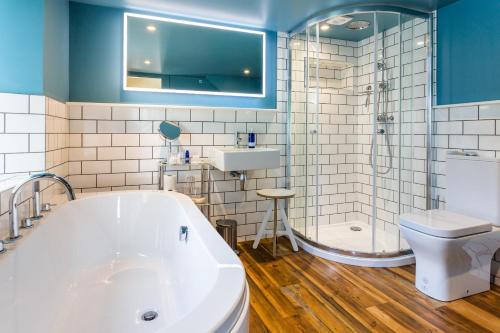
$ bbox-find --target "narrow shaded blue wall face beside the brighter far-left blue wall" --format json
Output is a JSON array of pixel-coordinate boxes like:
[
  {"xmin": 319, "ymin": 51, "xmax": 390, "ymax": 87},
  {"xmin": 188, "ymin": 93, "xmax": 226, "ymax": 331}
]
[{"xmin": 43, "ymin": 0, "xmax": 69, "ymax": 101}]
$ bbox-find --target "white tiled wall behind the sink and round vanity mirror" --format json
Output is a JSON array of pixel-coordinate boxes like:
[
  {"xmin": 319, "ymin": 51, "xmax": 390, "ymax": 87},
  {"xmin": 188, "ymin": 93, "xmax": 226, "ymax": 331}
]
[{"xmin": 68, "ymin": 34, "xmax": 288, "ymax": 240}]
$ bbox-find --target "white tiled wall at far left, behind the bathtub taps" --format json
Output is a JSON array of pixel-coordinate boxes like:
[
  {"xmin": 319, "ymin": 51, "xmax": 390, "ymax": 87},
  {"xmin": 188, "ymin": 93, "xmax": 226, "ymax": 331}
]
[{"xmin": 0, "ymin": 93, "xmax": 70, "ymax": 238}]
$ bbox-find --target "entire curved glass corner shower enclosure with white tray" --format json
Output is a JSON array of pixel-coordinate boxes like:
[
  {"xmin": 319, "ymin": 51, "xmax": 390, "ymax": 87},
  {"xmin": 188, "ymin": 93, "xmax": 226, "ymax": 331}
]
[{"xmin": 287, "ymin": 9, "xmax": 432, "ymax": 265}]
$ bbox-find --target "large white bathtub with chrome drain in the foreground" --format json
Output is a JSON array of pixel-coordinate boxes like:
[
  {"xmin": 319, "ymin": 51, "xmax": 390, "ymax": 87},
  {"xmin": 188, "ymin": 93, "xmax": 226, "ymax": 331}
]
[{"xmin": 0, "ymin": 191, "xmax": 249, "ymax": 333}]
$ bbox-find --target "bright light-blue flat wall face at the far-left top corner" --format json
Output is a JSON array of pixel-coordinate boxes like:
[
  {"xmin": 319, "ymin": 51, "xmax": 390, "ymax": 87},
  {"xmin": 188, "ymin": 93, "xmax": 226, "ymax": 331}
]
[{"xmin": 0, "ymin": 0, "xmax": 44, "ymax": 94}]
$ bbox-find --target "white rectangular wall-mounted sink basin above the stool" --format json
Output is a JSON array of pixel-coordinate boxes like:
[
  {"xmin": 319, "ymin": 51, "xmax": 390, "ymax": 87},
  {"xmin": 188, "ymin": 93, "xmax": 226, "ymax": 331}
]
[{"xmin": 212, "ymin": 147, "xmax": 280, "ymax": 171}]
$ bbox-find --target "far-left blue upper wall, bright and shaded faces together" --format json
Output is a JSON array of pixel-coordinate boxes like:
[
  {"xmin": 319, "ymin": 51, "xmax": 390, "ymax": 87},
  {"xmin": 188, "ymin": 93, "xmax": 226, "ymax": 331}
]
[{"xmin": 0, "ymin": 0, "xmax": 69, "ymax": 102}]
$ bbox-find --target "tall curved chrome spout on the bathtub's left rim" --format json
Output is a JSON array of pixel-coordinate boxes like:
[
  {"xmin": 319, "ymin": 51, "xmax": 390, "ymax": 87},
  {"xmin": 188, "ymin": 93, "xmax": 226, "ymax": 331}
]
[{"xmin": 9, "ymin": 172, "xmax": 75, "ymax": 241}]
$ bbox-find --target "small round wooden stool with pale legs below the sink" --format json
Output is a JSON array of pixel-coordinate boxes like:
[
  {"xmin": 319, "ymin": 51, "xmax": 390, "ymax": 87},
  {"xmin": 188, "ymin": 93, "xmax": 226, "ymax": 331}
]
[{"xmin": 253, "ymin": 188, "xmax": 299, "ymax": 257}]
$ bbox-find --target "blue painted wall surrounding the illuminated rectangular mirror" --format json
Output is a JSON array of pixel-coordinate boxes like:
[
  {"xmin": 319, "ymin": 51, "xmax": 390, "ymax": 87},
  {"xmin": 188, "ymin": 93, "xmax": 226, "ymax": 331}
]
[{"xmin": 69, "ymin": 2, "xmax": 277, "ymax": 108}]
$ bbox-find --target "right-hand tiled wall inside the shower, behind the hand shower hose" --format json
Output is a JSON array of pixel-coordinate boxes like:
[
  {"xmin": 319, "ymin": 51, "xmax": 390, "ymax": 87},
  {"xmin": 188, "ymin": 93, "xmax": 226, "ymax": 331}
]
[{"xmin": 356, "ymin": 16, "xmax": 428, "ymax": 226}]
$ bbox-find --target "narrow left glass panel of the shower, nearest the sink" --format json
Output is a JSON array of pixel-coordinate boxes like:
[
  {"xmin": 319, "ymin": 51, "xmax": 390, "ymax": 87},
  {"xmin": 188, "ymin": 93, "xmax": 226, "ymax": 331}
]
[{"xmin": 289, "ymin": 25, "xmax": 319, "ymax": 240}]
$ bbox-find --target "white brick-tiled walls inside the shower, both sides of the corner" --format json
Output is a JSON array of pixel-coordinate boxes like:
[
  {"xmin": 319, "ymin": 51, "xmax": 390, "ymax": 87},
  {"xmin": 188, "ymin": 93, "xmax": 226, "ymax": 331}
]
[{"xmin": 290, "ymin": 19, "xmax": 427, "ymax": 236}]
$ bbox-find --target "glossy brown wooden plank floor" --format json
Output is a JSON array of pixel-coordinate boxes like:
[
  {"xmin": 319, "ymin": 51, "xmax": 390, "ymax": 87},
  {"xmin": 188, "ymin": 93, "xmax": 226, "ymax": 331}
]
[{"xmin": 239, "ymin": 239, "xmax": 500, "ymax": 333}]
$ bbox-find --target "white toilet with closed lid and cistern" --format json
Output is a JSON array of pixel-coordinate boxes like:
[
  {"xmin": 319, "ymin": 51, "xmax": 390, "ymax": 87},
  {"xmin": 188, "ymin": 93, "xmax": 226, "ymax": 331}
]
[{"xmin": 399, "ymin": 154, "xmax": 500, "ymax": 301}]
